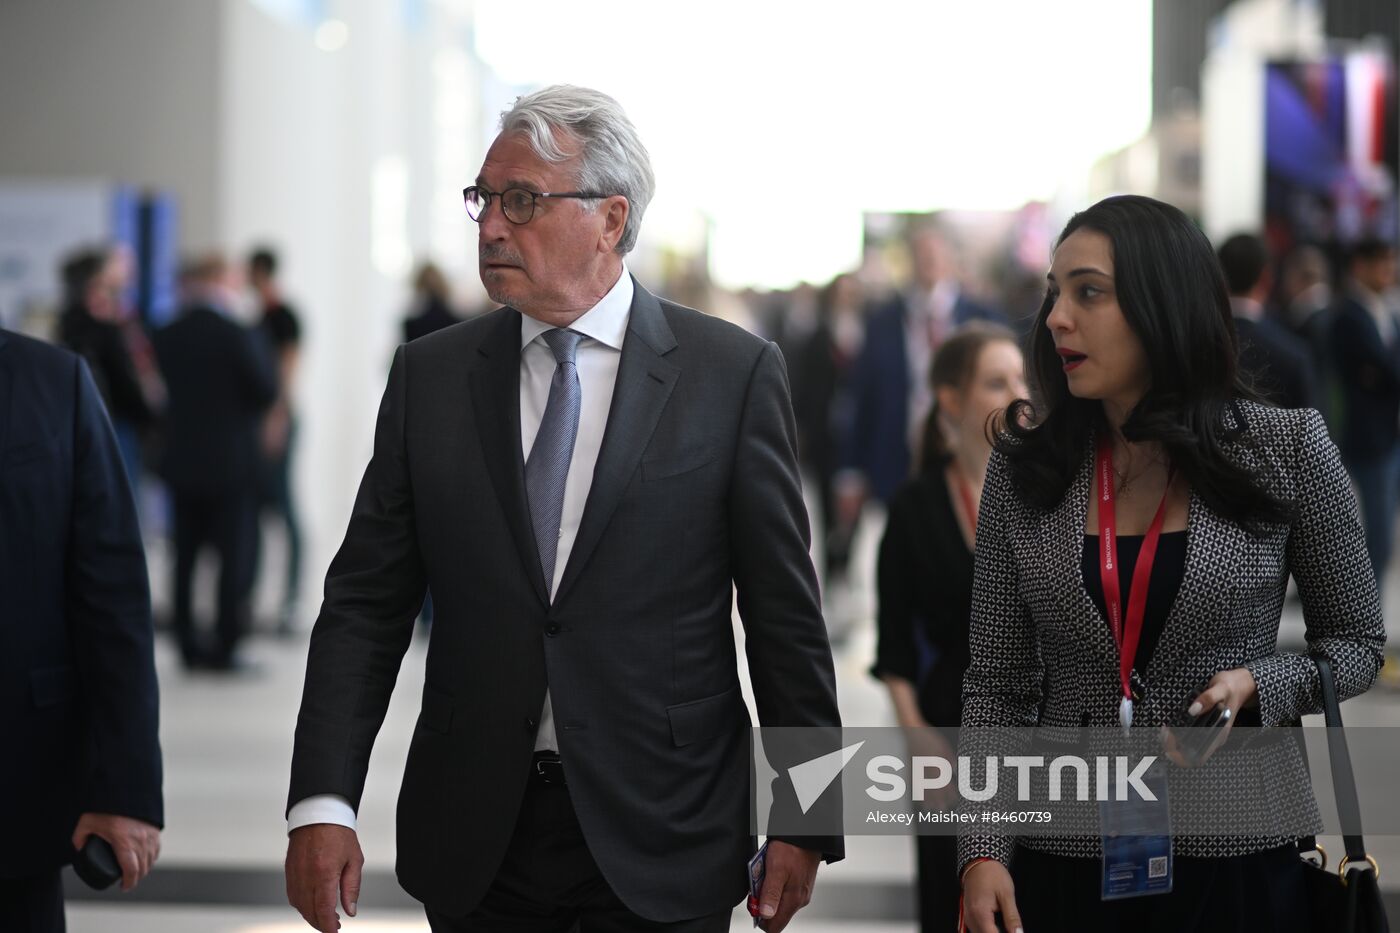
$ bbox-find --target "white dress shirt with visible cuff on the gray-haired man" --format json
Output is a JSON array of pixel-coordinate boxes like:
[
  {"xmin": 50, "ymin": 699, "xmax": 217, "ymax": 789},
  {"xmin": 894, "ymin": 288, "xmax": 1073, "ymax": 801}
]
[{"xmin": 287, "ymin": 265, "xmax": 633, "ymax": 832}]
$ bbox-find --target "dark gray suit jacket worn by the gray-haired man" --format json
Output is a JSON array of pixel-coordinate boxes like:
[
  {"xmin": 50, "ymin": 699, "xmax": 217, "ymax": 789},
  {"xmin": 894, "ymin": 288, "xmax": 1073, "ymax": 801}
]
[{"xmin": 290, "ymin": 275, "xmax": 840, "ymax": 920}]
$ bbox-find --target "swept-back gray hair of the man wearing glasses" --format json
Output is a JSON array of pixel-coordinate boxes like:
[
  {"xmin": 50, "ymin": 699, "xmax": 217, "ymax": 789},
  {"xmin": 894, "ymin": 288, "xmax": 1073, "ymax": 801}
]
[{"xmin": 501, "ymin": 84, "xmax": 657, "ymax": 255}]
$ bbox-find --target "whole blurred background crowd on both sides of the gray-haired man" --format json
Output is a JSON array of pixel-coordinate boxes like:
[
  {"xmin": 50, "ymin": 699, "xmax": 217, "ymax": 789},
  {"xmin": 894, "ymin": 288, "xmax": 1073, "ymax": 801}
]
[{"xmin": 38, "ymin": 219, "xmax": 1400, "ymax": 680}]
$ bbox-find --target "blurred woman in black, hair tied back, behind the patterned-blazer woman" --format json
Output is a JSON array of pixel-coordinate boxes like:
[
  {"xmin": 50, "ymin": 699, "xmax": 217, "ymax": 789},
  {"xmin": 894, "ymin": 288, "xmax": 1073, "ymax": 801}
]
[{"xmin": 871, "ymin": 321, "xmax": 1026, "ymax": 933}]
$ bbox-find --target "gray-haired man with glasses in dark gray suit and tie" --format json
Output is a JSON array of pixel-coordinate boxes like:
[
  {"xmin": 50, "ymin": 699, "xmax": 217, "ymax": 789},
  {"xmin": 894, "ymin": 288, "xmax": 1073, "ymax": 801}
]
[{"xmin": 278, "ymin": 87, "xmax": 841, "ymax": 933}]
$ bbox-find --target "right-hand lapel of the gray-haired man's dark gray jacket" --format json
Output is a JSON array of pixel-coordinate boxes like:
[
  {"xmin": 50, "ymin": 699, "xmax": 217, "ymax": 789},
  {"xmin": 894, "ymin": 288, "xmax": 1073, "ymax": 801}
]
[{"xmin": 551, "ymin": 279, "xmax": 680, "ymax": 604}]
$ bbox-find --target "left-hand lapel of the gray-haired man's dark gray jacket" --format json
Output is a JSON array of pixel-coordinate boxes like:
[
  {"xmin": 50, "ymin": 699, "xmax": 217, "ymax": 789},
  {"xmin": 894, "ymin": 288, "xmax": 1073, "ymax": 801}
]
[{"xmin": 472, "ymin": 310, "xmax": 549, "ymax": 605}]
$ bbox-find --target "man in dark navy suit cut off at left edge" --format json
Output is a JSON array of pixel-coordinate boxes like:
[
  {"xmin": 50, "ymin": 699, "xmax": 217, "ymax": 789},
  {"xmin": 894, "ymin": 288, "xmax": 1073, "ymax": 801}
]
[{"xmin": 0, "ymin": 331, "xmax": 164, "ymax": 933}]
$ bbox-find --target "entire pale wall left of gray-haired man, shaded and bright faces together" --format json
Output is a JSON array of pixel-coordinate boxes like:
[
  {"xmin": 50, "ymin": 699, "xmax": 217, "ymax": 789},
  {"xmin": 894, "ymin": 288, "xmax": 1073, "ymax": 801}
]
[{"xmin": 0, "ymin": 0, "xmax": 482, "ymax": 616}]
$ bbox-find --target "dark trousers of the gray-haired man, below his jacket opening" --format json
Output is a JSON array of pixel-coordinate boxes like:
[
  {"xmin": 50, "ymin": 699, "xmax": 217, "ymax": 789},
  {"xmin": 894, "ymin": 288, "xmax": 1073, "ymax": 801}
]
[{"xmin": 427, "ymin": 780, "xmax": 731, "ymax": 933}]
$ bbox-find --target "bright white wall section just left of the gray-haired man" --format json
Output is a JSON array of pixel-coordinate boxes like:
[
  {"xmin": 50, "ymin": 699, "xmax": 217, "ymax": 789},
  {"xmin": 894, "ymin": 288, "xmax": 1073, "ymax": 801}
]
[{"xmin": 220, "ymin": 0, "xmax": 479, "ymax": 601}]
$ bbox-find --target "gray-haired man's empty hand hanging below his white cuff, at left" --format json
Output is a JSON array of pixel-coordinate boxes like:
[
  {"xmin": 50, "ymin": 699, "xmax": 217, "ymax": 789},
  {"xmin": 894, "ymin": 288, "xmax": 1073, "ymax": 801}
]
[{"xmin": 287, "ymin": 822, "xmax": 364, "ymax": 933}]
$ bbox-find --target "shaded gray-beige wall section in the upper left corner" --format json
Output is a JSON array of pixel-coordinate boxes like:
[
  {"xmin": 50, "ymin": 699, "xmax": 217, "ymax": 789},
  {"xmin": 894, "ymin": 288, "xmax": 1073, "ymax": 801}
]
[{"xmin": 0, "ymin": 0, "xmax": 223, "ymax": 247}]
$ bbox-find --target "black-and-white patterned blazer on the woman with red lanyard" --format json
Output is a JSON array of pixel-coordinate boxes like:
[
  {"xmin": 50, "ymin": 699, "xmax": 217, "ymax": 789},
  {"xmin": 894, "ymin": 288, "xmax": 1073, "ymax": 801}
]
[{"xmin": 958, "ymin": 402, "xmax": 1385, "ymax": 870}]
